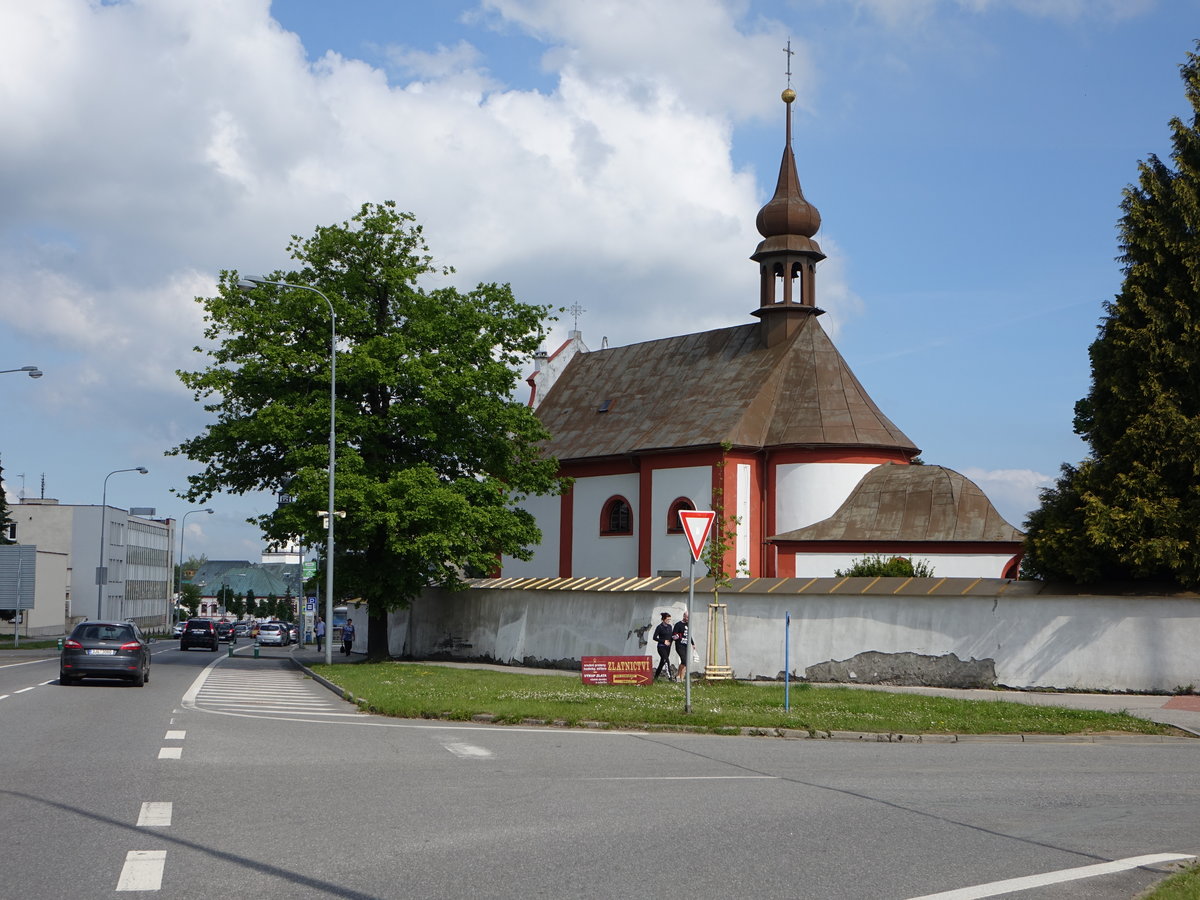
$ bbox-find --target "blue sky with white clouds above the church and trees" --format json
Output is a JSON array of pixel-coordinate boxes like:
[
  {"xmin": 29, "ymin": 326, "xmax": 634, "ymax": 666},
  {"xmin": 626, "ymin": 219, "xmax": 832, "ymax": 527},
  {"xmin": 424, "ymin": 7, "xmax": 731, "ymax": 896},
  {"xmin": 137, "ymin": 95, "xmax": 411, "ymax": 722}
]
[{"xmin": 0, "ymin": 0, "xmax": 1200, "ymax": 558}]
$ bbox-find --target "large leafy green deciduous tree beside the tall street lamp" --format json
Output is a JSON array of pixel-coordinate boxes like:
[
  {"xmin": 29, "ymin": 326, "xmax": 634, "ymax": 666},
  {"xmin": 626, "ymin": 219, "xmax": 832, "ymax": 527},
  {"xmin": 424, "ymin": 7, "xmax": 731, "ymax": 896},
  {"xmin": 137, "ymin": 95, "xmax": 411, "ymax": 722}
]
[{"xmin": 172, "ymin": 202, "xmax": 565, "ymax": 658}]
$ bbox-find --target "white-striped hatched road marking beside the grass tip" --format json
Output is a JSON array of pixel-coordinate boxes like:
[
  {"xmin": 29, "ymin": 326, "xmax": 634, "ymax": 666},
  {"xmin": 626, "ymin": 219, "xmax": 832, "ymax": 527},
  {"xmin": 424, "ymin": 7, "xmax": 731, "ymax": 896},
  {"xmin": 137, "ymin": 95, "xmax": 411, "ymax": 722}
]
[{"xmin": 193, "ymin": 659, "xmax": 361, "ymax": 718}]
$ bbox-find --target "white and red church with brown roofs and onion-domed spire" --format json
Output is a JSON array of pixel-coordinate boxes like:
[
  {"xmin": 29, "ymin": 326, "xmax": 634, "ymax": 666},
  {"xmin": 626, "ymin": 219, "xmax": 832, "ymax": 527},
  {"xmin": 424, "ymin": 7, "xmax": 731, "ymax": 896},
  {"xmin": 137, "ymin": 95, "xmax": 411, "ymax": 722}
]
[{"xmin": 503, "ymin": 88, "xmax": 1022, "ymax": 578}]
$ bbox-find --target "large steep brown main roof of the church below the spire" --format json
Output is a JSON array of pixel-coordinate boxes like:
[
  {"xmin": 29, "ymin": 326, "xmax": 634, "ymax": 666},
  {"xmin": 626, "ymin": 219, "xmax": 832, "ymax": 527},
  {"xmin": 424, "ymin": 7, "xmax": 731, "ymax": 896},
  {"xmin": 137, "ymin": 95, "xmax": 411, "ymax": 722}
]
[{"xmin": 538, "ymin": 316, "xmax": 918, "ymax": 461}]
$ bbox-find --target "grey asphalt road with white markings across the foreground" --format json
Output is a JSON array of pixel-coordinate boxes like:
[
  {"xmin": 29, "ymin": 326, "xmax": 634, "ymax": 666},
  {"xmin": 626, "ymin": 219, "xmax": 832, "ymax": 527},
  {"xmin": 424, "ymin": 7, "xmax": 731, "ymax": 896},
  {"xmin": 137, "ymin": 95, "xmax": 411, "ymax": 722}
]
[{"xmin": 0, "ymin": 642, "xmax": 1200, "ymax": 900}]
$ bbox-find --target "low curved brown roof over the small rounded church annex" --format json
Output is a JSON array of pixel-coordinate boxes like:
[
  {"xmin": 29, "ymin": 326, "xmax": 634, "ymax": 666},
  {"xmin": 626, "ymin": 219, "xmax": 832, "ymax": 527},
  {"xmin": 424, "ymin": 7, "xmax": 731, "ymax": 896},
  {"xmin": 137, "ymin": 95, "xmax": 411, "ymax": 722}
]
[{"xmin": 768, "ymin": 463, "xmax": 1024, "ymax": 542}]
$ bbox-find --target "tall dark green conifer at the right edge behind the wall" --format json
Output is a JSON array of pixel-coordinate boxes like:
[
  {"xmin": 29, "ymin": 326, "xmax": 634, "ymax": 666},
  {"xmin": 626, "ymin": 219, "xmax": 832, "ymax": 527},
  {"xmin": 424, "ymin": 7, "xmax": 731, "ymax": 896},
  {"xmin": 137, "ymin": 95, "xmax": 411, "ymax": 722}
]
[{"xmin": 1022, "ymin": 42, "xmax": 1200, "ymax": 588}]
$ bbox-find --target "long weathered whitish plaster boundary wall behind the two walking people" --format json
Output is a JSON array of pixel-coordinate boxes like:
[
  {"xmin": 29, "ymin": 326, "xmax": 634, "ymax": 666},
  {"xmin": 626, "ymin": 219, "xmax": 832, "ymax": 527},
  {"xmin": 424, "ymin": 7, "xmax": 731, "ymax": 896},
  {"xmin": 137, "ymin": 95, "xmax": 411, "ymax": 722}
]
[{"xmin": 404, "ymin": 578, "xmax": 1200, "ymax": 692}]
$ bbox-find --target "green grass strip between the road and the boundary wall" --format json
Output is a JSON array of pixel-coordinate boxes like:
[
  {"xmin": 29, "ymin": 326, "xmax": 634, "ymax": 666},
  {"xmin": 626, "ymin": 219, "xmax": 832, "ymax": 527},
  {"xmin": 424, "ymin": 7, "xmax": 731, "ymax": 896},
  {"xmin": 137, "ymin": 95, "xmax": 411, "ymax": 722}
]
[{"xmin": 304, "ymin": 662, "xmax": 1176, "ymax": 734}]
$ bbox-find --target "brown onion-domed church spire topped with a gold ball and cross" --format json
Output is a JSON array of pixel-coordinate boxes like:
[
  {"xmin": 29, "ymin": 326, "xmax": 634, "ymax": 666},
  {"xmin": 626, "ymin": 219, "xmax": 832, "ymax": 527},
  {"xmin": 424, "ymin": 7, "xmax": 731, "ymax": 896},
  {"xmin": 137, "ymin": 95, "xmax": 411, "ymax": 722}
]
[{"xmin": 750, "ymin": 41, "xmax": 826, "ymax": 347}]
